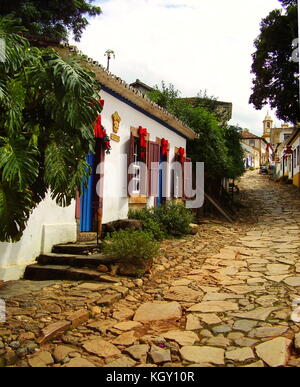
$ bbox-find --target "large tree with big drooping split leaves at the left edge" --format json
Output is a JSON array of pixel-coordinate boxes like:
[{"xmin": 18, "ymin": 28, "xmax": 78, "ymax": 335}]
[{"xmin": 0, "ymin": 18, "xmax": 101, "ymax": 241}]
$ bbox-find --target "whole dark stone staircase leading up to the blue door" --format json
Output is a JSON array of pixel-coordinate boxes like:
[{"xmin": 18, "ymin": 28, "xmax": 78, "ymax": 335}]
[{"xmin": 23, "ymin": 241, "xmax": 115, "ymax": 282}]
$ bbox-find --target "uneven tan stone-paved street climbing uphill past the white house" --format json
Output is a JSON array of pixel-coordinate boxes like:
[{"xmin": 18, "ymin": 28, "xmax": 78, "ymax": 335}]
[{"xmin": 0, "ymin": 171, "xmax": 300, "ymax": 367}]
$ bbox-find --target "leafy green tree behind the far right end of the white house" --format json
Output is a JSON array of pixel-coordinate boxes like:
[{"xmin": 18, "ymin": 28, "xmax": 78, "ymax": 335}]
[{"xmin": 148, "ymin": 82, "xmax": 244, "ymax": 180}]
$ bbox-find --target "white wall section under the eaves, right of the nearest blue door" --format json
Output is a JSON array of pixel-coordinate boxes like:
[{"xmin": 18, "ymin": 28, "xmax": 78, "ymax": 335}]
[{"xmin": 101, "ymin": 90, "xmax": 186, "ymax": 223}]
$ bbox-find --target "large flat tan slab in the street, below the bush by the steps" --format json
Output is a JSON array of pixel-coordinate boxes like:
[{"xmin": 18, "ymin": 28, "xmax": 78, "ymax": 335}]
[{"xmin": 133, "ymin": 301, "xmax": 182, "ymax": 322}]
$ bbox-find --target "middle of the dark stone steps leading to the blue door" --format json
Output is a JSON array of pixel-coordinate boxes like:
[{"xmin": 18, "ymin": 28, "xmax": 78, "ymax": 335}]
[{"xmin": 37, "ymin": 253, "xmax": 115, "ymax": 267}]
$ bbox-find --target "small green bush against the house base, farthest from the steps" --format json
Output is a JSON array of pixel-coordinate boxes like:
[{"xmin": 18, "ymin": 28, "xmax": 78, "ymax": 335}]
[{"xmin": 153, "ymin": 201, "xmax": 194, "ymax": 235}]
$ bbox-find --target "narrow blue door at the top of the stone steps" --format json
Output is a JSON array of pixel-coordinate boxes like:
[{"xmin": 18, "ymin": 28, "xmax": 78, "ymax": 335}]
[{"xmin": 80, "ymin": 153, "xmax": 95, "ymax": 232}]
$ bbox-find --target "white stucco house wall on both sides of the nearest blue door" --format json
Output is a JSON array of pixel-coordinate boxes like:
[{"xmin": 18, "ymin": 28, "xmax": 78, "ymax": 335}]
[{"xmin": 0, "ymin": 91, "xmax": 186, "ymax": 281}]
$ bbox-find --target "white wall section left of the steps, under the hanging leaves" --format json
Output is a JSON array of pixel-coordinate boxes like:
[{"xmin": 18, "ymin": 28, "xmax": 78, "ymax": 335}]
[{"xmin": 0, "ymin": 196, "xmax": 76, "ymax": 281}]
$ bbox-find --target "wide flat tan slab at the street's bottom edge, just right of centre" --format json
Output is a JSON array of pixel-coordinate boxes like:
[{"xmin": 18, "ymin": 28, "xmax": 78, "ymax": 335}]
[{"xmin": 179, "ymin": 346, "xmax": 225, "ymax": 365}]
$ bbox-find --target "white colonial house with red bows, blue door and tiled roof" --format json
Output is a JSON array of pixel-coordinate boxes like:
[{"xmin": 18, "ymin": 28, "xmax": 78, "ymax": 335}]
[{"xmin": 0, "ymin": 46, "xmax": 196, "ymax": 281}]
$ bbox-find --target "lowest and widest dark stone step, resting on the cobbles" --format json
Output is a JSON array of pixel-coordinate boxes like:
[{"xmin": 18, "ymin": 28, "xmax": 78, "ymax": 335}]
[{"xmin": 24, "ymin": 264, "xmax": 119, "ymax": 283}]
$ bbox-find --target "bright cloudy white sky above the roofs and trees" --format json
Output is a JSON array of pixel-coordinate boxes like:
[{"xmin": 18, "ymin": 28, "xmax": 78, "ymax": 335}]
[{"xmin": 72, "ymin": 0, "xmax": 286, "ymax": 134}]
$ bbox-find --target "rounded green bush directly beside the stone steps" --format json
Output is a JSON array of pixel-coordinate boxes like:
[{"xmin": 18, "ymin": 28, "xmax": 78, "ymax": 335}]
[{"xmin": 103, "ymin": 230, "xmax": 159, "ymax": 267}]
